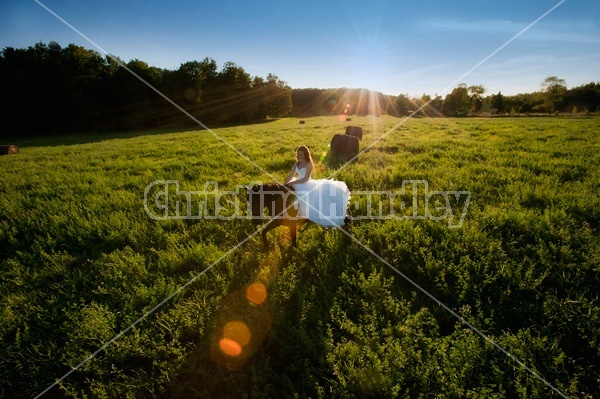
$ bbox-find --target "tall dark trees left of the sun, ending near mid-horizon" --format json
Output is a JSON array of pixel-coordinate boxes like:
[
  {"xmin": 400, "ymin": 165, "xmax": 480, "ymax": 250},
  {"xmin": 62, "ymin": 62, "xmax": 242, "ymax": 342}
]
[{"xmin": 0, "ymin": 42, "xmax": 291, "ymax": 136}]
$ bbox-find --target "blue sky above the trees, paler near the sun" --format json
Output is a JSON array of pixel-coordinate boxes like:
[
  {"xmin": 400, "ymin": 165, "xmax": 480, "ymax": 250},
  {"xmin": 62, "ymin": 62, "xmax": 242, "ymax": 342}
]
[{"xmin": 0, "ymin": 0, "xmax": 600, "ymax": 96}]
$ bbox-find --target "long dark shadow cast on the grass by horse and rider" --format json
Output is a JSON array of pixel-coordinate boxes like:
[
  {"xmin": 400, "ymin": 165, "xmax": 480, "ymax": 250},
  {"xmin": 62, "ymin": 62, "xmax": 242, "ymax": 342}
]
[{"xmin": 171, "ymin": 226, "xmax": 350, "ymax": 398}]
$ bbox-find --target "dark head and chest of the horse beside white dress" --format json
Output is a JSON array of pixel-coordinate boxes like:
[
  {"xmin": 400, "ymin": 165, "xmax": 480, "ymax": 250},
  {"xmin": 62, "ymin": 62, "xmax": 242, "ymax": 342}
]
[{"xmin": 244, "ymin": 183, "xmax": 295, "ymax": 224}]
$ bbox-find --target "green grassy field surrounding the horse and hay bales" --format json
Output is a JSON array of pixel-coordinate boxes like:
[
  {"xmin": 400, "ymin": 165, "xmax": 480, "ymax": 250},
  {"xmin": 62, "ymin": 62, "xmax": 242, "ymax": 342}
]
[{"xmin": 0, "ymin": 117, "xmax": 600, "ymax": 398}]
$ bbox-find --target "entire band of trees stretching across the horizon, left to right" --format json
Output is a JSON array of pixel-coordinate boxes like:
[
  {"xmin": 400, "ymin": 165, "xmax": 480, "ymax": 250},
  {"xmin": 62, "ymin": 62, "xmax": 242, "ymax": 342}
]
[{"xmin": 0, "ymin": 42, "xmax": 600, "ymax": 137}]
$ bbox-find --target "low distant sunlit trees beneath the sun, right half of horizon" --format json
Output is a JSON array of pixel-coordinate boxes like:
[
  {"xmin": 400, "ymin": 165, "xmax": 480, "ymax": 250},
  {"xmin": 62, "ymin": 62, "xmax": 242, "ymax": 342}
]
[{"xmin": 292, "ymin": 76, "xmax": 600, "ymax": 117}]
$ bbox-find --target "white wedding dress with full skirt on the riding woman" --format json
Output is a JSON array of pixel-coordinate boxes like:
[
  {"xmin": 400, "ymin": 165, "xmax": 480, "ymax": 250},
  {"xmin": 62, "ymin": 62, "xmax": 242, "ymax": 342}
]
[{"xmin": 293, "ymin": 166, "xmax": 350, "ymax": 227}]
